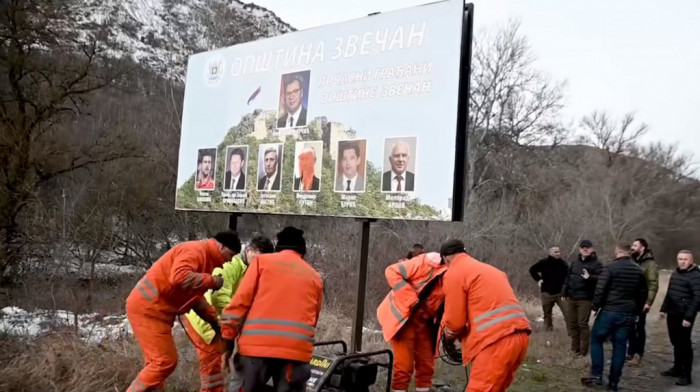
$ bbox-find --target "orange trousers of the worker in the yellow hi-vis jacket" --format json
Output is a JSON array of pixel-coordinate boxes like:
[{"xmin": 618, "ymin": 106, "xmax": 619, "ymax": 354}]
[{"xmin": 180, "ymin": 316, "xmax": 225, "ymax": 392}]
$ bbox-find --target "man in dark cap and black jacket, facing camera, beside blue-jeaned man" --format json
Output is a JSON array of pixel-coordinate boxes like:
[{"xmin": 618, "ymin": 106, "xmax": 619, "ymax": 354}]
[{"xmin": 562, "ymin": 240, "xmax": 603, "ymax": 356}]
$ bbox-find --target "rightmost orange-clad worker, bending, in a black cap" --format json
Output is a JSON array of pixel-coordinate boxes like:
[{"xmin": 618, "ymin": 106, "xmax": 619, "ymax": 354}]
[{"xmin": 440, "ymin": 240, "xmax": 532, "ymax": 392}]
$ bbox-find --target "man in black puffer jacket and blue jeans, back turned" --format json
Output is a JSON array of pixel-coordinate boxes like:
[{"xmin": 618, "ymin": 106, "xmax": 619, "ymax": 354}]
[{"xmin": 581, "ymin": 244, "xmax": 648, "ymax": 391}]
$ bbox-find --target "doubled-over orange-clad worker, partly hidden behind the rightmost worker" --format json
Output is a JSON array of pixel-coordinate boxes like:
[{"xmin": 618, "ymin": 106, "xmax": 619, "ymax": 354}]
[{"xmin": 377, "ymin": 252, "xmax": 447, "ymax": 392}]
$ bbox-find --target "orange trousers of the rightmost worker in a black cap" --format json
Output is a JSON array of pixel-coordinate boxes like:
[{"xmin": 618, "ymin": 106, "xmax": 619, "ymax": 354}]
[{"xmin": 465, "ymin": 332, "xmax": 530, "ymax": 392}]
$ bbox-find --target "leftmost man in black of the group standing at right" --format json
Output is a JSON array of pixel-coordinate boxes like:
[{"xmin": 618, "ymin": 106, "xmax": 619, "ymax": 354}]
[{"xmin": 530, "ymin": 246, "xmax": 569, "ymax": 331}]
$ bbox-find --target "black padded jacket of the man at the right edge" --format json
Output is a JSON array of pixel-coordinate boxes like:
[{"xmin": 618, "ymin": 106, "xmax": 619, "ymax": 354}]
[{"xmin": 661, "ymin": 265, "xmax": 700, "ymax": 323}]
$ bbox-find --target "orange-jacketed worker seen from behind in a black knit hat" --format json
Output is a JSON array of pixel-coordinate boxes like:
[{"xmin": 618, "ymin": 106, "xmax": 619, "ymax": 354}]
[{"xmin": 221, "ymin": 226, "xmax": 323, "ymax": 392}]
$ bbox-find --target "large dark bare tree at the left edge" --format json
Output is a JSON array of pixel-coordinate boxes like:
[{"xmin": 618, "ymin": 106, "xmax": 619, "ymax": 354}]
[{"xmin": 0, "ymin": 0, "xmax": 138, "ymax": 278}]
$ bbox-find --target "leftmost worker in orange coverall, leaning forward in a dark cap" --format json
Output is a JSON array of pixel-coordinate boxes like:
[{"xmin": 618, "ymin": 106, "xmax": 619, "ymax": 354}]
[{"xmin": 126, "ymin": 231, "xmax": 241, "ymax": 392}]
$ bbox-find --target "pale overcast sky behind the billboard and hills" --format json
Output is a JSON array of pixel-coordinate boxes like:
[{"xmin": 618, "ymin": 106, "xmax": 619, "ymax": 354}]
[{"xmin": 253, "ymin": 0, "xmax": 700, "ymax": 162}]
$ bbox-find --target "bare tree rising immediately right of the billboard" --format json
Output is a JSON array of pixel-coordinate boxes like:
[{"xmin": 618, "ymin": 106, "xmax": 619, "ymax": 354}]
[{"xmin": 467, "ymin": 22, "xmax": 566, "ymax": 208}]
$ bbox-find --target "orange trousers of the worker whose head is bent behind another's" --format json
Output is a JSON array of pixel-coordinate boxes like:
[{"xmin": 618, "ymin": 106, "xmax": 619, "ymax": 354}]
[{"xmin": 391, "ymin": 320, "xmax": 435, "ymax": 392}]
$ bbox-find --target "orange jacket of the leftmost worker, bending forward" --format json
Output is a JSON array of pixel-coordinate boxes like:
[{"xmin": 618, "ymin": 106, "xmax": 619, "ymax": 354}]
[{"xmin": 127, "ymin": 238, "xmax": 224, "ymax": 322}]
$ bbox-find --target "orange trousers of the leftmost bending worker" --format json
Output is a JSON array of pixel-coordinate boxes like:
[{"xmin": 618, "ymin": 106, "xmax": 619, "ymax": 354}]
[{"xmin": 126, "ymin": 300, "xmax": 177, "ymax": 392}]
